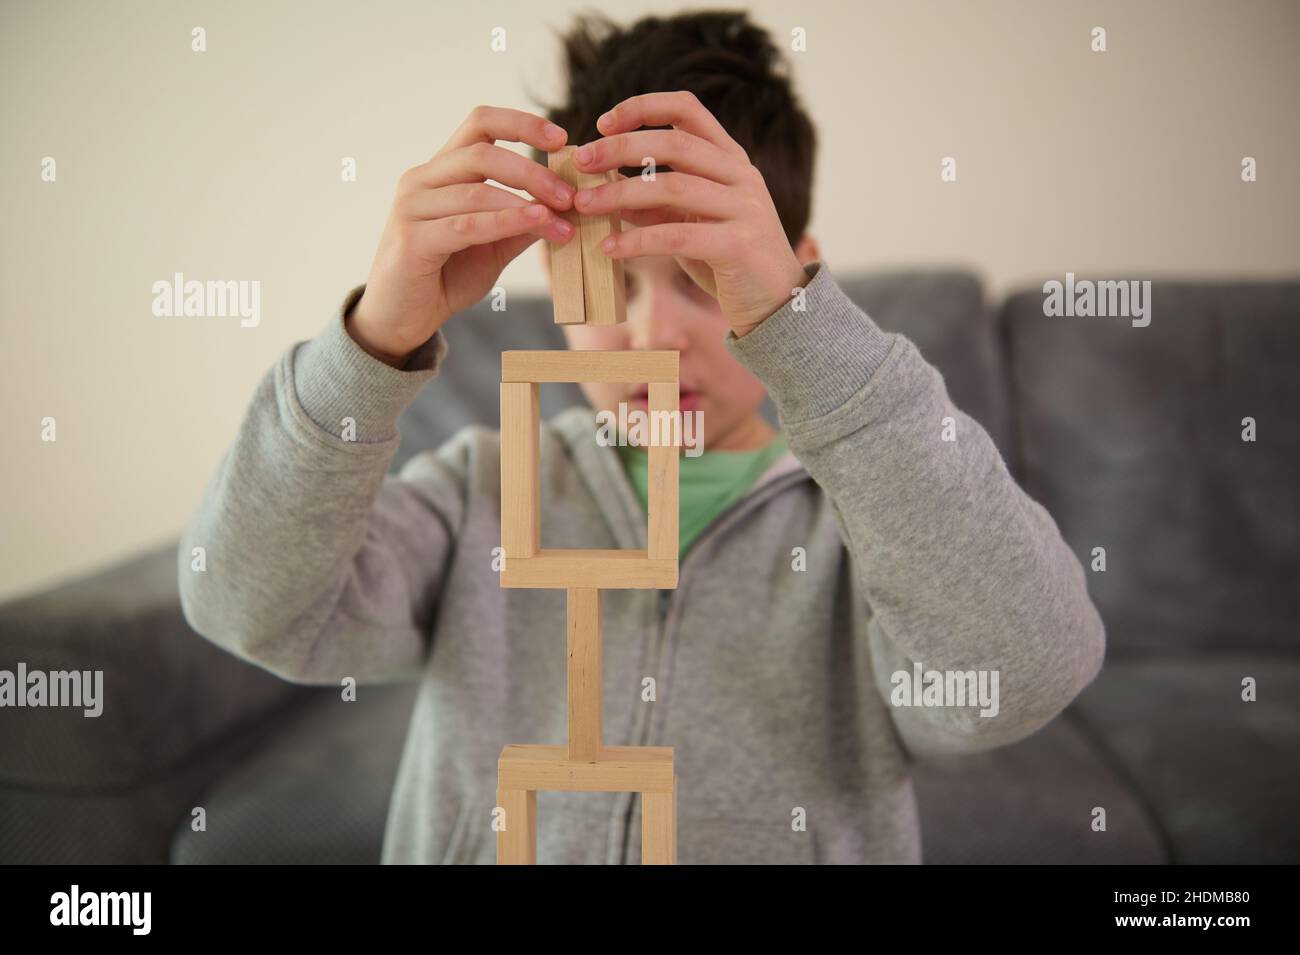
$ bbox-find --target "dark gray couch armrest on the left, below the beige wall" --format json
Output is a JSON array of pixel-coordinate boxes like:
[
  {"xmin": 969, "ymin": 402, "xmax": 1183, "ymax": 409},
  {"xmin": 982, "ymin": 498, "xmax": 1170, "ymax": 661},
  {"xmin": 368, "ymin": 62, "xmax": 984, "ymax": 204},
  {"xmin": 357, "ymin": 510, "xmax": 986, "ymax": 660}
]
[{"xmin": 0, "ymin": 543, "xmax": 304, "ymax": 789}]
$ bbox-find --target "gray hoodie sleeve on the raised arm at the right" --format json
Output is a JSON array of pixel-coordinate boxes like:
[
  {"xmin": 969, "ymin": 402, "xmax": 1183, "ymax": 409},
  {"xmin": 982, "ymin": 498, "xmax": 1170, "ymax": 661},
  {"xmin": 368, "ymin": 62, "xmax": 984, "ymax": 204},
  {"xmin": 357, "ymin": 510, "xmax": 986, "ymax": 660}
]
[{"xmin": 727, "ymin": 262, "xmax": 1105, "ymax": 758}]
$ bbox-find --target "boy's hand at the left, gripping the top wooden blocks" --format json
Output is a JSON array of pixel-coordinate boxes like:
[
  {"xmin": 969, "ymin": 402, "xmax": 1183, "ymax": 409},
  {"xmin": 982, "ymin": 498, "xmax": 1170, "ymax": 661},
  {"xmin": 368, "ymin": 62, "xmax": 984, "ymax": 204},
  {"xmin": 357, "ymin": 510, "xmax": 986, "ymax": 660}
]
[{"xmin": 347, "ymin": 107, "xmax": 573, "ymax": 368}]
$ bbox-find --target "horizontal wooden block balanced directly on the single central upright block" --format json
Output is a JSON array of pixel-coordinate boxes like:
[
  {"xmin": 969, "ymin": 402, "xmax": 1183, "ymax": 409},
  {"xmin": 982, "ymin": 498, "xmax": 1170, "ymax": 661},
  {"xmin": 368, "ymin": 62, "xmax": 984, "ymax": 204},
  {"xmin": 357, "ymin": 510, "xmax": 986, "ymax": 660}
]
[{"xmin": 501, "ymin": 548, "xmax": 677, "ymax": 590}]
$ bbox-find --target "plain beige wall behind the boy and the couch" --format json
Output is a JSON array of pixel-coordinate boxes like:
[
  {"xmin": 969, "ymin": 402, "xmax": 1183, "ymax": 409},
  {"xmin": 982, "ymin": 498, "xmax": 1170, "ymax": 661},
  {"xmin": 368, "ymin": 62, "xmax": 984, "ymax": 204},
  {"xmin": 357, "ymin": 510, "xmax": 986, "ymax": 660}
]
[{"xmin": 0, "ymin": 0, "xmax": 1300, "ymax": 596}]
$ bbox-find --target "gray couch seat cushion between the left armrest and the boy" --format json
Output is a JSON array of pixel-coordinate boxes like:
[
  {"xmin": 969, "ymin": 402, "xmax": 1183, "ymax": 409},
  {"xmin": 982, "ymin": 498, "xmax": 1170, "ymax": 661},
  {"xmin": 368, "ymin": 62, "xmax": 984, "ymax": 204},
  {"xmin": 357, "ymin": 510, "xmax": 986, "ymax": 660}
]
[{"xmin": 172, "ymin": 683, "xmax": 417, "ymax": 865}]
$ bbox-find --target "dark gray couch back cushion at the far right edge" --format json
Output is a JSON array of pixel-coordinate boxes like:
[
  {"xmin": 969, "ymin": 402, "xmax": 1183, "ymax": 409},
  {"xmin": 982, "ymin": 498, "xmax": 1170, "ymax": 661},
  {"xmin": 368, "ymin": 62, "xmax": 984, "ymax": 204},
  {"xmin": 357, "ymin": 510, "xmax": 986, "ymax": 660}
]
[{"xmin": 1005, "ymin": 282, "xmax": 1300, "ymax": 652}]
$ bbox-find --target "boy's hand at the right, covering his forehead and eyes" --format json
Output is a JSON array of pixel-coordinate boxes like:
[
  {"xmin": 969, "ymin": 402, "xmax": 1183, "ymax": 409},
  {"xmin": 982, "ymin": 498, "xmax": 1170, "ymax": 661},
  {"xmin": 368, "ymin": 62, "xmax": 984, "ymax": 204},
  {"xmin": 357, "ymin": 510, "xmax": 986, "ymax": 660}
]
[{"xmin": 575, "ymin": 92, "xmax": 807, "ymax": 337}]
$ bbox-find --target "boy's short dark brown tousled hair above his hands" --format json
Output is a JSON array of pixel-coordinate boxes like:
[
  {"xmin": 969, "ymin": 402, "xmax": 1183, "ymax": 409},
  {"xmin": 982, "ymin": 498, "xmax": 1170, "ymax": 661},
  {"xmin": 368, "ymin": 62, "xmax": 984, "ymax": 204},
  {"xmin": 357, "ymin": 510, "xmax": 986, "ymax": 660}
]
[{"xmin": 533, "ymin": 10, "xmax": 816, "ymax": 246}]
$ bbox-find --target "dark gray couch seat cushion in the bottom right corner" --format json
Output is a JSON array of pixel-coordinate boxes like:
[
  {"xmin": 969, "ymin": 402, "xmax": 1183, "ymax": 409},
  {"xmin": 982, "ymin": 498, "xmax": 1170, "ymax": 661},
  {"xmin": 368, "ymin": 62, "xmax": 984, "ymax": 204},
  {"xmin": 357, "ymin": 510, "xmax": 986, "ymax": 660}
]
[{"xmin": 1074, "ymin": 655, "xmax": 1300, "ymax": 865}]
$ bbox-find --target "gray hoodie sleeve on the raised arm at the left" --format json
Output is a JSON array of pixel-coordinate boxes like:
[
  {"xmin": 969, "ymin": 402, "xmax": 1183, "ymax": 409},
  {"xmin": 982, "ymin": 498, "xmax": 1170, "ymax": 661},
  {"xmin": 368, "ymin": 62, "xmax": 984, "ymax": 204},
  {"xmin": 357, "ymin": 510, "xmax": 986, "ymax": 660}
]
[{"xmin": 177, "ymin": 286, "xmax": 464, "ymax": 685}]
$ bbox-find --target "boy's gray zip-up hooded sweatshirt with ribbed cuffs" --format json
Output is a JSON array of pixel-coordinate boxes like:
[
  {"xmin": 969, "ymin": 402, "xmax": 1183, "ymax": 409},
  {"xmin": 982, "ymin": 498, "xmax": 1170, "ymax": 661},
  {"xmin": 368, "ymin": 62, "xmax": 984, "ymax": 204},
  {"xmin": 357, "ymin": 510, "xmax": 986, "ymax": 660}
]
[{"xmin": 178, "ymin": 262, "xmax": 1105, "ymax": 863}]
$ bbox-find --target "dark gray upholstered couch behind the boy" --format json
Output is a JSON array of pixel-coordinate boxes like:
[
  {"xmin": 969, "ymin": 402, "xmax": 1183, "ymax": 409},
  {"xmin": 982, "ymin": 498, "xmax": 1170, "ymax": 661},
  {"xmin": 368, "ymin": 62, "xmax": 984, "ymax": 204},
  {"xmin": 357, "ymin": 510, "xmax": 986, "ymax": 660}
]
[{"xmin": 0, "ymin": 272, "xmax": 1300, "ymax": 863}]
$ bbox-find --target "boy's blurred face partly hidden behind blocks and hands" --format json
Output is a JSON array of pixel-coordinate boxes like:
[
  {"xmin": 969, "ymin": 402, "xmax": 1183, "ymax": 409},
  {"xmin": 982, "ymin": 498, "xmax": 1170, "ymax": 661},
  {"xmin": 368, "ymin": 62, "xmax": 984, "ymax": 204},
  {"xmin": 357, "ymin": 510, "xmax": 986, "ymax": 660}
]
[{"xmin": 541, "ymin": 250, "xmax": 774, "ymax": 451}]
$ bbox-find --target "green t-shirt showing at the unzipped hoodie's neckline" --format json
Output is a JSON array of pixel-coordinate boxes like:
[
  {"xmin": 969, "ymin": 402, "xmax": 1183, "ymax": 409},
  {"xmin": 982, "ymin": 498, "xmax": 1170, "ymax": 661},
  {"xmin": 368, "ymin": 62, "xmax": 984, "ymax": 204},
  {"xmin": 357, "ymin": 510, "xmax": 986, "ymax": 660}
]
[{"xmin": 619, "ymin": 434, "xmax": 785, "ymax": 557}]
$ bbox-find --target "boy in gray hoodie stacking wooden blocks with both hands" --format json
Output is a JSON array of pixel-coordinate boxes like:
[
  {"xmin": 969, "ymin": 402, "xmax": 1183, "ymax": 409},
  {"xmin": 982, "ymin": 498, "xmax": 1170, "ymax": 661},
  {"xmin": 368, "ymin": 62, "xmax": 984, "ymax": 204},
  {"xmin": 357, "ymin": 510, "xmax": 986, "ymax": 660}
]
[{"xmin": 181, "ymin": 13, "xmax": 1104, "ymax": 863}]
